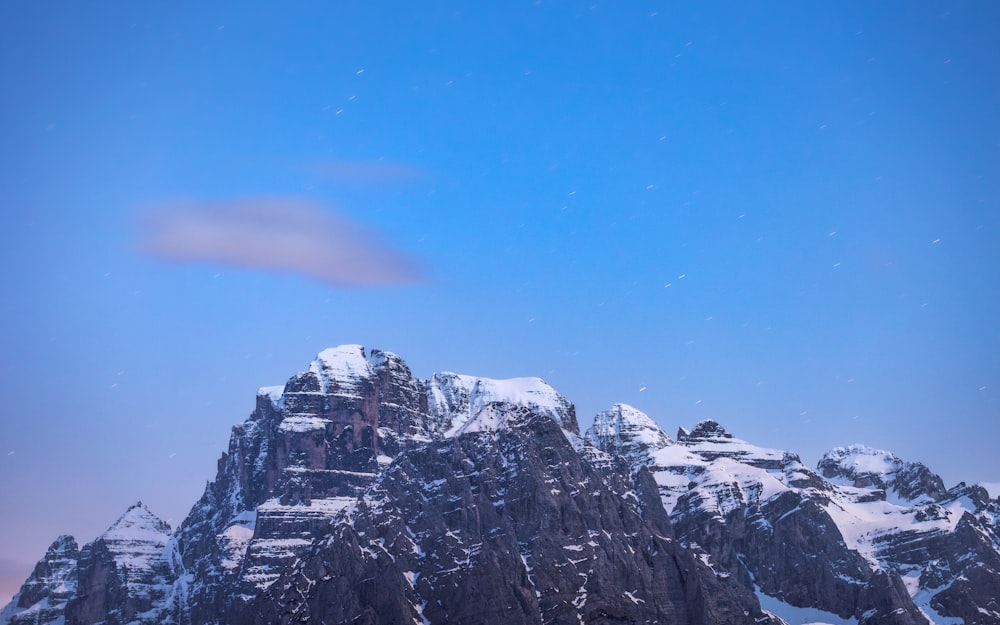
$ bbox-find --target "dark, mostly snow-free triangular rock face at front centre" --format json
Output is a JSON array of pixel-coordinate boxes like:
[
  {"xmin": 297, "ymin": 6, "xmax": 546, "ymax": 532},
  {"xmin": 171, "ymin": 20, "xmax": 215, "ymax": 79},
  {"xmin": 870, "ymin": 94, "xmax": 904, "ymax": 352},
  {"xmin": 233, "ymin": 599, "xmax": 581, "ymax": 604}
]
[{"xmin": 255, "ymin": 404, "xmax": 766, "ymax": 625}]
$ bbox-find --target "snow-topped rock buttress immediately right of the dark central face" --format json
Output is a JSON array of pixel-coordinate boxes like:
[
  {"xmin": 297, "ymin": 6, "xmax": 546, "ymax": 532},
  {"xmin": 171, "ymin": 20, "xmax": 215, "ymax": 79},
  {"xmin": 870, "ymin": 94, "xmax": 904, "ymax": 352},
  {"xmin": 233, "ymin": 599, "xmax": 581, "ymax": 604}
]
[{"xmin": 595, "ymin": 414, "xmax": 925, "ymax": 625}]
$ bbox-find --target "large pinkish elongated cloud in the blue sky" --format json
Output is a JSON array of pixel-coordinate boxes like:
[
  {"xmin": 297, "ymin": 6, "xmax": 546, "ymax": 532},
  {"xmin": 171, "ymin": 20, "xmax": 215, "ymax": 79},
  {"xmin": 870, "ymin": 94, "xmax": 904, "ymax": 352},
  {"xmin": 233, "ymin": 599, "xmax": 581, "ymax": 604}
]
[{"xmin": 142, "ymin": 197, "xmax": 422, "ymax": 286}]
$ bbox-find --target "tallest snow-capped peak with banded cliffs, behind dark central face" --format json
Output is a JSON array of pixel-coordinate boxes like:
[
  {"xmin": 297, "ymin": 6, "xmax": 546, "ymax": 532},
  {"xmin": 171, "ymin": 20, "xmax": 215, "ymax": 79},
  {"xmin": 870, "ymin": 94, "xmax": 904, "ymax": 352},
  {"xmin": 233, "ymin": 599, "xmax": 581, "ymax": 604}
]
[{"xmin": 174, "ymin": 345, "xmax": 577, "ymax": 623}]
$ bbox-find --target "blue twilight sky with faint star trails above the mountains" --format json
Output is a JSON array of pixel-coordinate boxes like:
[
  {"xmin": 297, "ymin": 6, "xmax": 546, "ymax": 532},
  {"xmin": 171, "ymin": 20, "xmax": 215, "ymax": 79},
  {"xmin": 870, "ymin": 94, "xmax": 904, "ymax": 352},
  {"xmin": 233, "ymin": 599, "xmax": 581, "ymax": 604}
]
[{"xmin": 0, "ymin": 0, "xmax": 1000, "ymax": 602}]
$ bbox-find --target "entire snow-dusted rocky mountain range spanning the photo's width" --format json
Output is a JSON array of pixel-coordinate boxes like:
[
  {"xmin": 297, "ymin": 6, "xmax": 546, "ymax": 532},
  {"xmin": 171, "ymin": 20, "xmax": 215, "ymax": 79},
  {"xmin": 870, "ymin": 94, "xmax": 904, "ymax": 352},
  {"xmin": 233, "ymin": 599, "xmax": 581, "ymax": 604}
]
[{"xmin": 0, "ymin": 345, "xmax": 1000, "ymax": 625}]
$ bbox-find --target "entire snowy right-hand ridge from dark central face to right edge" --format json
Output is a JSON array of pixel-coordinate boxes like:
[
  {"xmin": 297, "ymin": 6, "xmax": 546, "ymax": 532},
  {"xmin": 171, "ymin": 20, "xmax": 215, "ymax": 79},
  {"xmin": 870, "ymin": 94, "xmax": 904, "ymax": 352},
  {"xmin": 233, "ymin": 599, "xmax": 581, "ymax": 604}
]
[{"xmin": 587, "ymin": 410, "xmax": 1000, "ymax": 624}]
